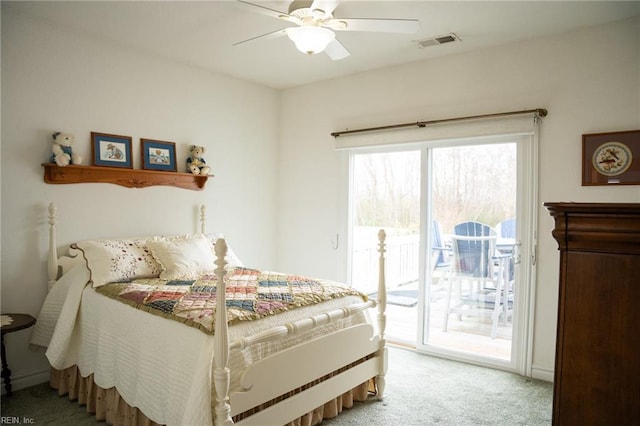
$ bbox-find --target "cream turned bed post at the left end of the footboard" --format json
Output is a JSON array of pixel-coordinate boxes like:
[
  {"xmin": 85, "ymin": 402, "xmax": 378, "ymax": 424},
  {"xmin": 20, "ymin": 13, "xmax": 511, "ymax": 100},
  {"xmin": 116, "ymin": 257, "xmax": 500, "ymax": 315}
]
[{"xmin": 213, "ymin": 238, "xmax": 233, "ymax": 426}]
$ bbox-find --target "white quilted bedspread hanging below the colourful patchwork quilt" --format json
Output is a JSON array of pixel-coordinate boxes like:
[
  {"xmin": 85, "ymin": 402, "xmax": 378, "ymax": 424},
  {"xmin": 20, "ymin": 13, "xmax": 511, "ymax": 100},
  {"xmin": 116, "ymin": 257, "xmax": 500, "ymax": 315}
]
[{"xmin": 32, "ymin": 266, "xmax": 368, "ymax": 425}]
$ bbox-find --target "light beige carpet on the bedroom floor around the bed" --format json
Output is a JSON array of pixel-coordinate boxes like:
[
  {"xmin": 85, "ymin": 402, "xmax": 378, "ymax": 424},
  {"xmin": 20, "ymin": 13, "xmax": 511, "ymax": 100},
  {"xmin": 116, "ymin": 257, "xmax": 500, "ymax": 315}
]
[{"xmin": 1, "ymin": 347, "xmax": 552, "ymax": 426}]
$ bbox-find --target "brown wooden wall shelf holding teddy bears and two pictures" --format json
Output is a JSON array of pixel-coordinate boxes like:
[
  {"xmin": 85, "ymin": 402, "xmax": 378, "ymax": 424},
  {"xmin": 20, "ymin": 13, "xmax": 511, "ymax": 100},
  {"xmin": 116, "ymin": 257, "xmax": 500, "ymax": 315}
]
[{"xmin": 42, "ymin": 163, "xmax": 209, "ymax": 191}]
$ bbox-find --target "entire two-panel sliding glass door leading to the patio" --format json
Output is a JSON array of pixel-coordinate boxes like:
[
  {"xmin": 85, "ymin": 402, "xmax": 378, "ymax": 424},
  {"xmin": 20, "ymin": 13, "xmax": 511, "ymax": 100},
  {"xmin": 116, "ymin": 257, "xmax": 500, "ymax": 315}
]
[{"xmin": 349, "ymin": 132, "xmax": 535, "ymax": 374}]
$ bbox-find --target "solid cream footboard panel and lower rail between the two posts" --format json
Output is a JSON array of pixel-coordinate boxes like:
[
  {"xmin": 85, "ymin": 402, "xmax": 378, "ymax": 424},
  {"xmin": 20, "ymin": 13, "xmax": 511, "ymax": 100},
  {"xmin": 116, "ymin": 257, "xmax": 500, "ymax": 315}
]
[{"xmin": 230, "ymin": 324, "xmax": 384, "ymax": 425}]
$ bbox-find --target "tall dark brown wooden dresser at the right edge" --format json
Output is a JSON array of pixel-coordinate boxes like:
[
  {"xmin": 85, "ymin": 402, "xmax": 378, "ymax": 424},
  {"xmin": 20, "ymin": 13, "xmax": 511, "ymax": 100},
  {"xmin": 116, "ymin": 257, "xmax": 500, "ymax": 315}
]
[{"xmin": 545, "ymin": 203, "xmax": 640, "ymax": 425}]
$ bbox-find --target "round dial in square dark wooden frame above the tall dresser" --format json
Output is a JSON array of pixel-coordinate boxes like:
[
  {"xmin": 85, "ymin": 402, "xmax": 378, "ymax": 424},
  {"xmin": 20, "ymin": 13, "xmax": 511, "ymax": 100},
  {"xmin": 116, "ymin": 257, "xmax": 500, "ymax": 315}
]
[{"xmin": 582, "ymin": 130, "xmax": 640, "ymax": 186}]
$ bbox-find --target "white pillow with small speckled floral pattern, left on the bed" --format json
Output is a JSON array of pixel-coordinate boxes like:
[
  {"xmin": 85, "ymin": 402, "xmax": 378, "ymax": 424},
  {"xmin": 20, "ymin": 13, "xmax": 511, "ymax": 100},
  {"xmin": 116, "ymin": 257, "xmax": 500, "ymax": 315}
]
[{"xmin": 70, "ymin": 238, "xmax": 161, "ymax": 287}]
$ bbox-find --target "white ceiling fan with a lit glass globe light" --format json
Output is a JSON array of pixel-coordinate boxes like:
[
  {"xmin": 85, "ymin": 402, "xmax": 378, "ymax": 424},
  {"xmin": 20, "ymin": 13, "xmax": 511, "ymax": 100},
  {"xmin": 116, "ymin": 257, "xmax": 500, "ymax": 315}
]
[{"xmin": 233, "ymin": 0, "xmax": 420, "ymax": 61}]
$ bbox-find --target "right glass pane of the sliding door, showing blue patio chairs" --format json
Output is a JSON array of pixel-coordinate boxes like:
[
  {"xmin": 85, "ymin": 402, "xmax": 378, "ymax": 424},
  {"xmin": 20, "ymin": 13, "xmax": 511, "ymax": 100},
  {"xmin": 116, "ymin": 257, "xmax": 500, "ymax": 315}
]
[{"xmin": 417, "ymin": 140, "xmax": 519, "ymax": 366}]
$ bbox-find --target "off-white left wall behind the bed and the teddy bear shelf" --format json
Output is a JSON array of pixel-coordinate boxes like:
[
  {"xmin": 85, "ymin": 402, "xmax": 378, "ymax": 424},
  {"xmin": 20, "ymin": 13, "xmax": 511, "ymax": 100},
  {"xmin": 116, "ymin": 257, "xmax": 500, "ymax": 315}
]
[{"xmin": 1, "ymin": 10, "xmax": 279, "ymax": 387}]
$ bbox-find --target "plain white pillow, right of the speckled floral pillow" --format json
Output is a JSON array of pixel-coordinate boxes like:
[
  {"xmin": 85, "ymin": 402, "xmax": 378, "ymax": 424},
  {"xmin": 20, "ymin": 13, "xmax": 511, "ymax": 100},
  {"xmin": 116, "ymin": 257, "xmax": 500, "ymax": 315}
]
[{"xmin": 147, "ymin": 234, "xmax": 216, "ymax": 280}]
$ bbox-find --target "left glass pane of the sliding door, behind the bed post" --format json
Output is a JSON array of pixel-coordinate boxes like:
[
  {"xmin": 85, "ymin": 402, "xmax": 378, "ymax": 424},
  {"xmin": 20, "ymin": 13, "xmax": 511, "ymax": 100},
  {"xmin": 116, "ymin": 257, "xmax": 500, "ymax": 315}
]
[{"xmin": 351, "ymin": 151, "xmax": 420, "ymax": 303}]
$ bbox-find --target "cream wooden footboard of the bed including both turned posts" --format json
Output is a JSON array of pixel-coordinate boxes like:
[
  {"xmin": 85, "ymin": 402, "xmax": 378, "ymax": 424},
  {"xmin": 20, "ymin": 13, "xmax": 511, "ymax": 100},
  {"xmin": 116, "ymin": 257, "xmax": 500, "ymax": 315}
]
[{"xmin": 213, "ymin": 231, "xmax": 387, "ymax": 425}]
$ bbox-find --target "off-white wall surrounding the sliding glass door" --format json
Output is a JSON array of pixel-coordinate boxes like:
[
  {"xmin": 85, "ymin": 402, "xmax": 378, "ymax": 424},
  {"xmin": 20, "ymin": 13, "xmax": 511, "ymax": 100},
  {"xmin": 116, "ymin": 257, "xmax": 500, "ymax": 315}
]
[{"xmin": 278, "ymin": 19, "xmax": 640, "ymax": 378}]
